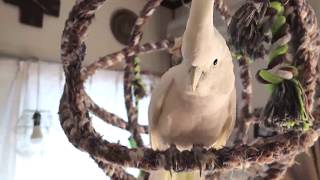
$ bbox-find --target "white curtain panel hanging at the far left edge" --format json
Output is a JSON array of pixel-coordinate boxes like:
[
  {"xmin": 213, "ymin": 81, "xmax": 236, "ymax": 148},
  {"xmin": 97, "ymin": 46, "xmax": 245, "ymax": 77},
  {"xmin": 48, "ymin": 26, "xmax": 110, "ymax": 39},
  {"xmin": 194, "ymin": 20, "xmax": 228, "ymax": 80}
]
[{"xmin": 0, "ymin": 59, "xmax": 29, "ymax": 180}]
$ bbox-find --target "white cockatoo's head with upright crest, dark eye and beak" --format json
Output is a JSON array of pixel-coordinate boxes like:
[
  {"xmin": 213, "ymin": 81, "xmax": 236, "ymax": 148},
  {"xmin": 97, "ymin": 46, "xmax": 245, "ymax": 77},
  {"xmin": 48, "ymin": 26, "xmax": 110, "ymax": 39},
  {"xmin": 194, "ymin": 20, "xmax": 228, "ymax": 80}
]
[{"xmin": 181, "ymin": 0, "xmax": 233, "ymax": 91}]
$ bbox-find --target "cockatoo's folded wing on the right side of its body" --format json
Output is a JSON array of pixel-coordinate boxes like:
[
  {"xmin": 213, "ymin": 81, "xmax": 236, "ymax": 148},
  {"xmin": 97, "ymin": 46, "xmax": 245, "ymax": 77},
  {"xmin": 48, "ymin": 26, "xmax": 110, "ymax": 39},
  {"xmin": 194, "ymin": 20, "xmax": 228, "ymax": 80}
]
[{"xmin": 213, "ymin": 89, "xmax": 237, "ymax": 149}]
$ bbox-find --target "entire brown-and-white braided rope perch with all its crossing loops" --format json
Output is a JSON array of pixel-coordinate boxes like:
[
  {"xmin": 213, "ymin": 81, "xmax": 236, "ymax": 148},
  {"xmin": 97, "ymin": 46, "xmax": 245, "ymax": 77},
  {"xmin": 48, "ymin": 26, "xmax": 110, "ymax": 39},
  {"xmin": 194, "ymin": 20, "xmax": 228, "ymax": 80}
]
[{"xmin": 59, "ymin": 0, "xmax": 320, "ymax": 179}]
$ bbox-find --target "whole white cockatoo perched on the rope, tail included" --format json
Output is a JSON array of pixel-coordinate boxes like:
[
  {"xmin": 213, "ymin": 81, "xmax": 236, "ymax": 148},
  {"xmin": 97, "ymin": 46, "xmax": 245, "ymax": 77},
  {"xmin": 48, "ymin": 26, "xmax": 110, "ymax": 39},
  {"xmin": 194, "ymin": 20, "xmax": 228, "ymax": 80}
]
[{"xmin": 149, "ymin": 0, "xmax": 236, "ymax": 180}]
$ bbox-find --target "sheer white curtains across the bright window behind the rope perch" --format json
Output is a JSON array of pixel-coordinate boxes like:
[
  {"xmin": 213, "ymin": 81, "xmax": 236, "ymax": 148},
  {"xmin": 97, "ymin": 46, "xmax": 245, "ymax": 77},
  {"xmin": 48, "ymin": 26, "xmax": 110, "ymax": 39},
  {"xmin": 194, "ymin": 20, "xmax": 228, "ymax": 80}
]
[{"xmin": 0, "ymin": 60, "xmax": 153, "ymax": 180}]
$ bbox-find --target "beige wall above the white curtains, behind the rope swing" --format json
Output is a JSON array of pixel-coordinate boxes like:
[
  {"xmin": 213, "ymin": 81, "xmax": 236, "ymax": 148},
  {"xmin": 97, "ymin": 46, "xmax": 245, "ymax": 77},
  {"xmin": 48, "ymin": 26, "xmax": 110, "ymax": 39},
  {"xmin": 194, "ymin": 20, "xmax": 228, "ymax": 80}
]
[{"xmin": 0, "ymin": 0, "xmax": 172, "ymax": 73}]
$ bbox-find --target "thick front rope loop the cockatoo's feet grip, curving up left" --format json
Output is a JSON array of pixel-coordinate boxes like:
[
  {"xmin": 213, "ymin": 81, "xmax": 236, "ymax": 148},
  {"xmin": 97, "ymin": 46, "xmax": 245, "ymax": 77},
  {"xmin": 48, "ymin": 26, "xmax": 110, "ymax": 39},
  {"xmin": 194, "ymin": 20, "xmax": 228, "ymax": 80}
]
[{"xmin": 59, "ymin": 0, "xmax": 320, "ymax": 179}]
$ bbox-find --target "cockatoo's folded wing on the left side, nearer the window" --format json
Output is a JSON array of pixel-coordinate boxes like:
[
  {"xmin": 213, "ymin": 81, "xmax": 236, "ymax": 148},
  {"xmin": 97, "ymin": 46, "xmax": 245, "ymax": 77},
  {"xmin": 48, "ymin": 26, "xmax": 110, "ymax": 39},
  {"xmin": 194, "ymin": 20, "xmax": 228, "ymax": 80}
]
[{"xmin": 148, "ymin": 67, "xmax": 175, "ymax": 149}]
